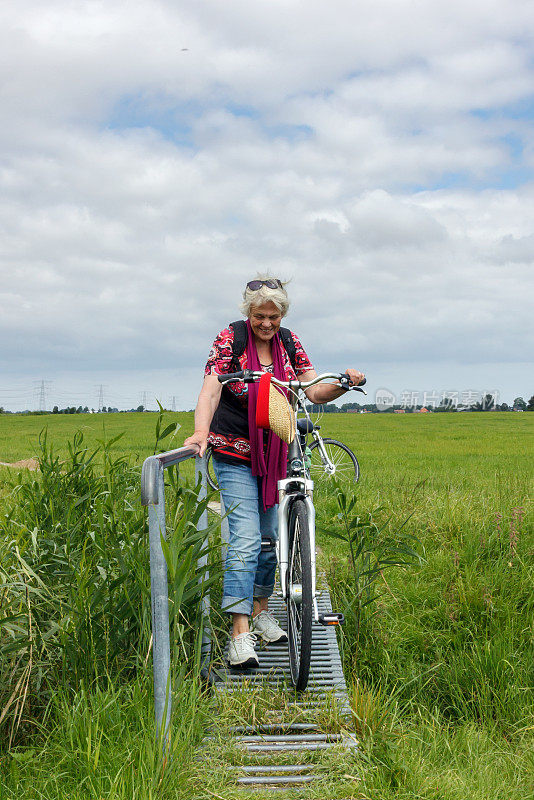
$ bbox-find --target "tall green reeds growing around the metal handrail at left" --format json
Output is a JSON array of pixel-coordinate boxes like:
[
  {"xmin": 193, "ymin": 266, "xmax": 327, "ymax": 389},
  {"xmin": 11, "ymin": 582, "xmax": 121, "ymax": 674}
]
[{"xmin": 0, "ymin": 424, "xmax": 216, "ymax": 749}]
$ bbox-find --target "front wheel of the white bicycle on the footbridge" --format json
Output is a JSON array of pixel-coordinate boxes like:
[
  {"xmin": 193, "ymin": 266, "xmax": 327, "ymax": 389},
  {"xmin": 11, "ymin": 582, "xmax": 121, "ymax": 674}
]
[{"xmin": 287, "ymin": 499, "xmax": 313, "ymax": 692}]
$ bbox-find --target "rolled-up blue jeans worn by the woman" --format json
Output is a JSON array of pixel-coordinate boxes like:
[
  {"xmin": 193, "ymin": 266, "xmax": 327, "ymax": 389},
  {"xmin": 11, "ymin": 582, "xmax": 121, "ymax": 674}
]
[{"xmin": 213, "ymin": 457, "xmax": 278, "ymax": 615}]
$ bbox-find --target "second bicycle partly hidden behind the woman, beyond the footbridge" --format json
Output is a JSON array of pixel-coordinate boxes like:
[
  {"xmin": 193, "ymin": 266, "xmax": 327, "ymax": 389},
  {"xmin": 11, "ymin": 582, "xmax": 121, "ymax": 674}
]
[{"xmin": 206, "ymin": 398, "xmax": 360, "ymax": 491}]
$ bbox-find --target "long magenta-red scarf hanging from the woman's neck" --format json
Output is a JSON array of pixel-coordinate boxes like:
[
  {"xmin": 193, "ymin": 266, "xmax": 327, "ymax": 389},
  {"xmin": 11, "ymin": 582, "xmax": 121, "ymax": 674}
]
[{"xmin": 247, "ymin": 319, "xmax": 287, "ymax": 511}]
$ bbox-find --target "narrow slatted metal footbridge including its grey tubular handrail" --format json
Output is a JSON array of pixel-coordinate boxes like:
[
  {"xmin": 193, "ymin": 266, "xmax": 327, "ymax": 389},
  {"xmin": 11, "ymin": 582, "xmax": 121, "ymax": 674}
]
[{"xmin": 141, "ymin": 447, "xmax": 357, "ymax": 792}]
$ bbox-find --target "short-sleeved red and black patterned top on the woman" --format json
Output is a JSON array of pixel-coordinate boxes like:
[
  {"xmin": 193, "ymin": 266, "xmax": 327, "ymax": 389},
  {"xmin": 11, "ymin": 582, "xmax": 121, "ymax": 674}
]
[{"xmin": 204, "ymin": 328, "xmax": 313, "ymax": 463}]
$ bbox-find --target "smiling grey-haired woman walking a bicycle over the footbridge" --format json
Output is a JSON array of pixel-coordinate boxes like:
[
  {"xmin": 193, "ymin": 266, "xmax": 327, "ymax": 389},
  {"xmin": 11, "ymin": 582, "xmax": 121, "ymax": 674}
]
[{"xmin": 184, "ymin": 277, "xmax": 364, "ymax": 668}]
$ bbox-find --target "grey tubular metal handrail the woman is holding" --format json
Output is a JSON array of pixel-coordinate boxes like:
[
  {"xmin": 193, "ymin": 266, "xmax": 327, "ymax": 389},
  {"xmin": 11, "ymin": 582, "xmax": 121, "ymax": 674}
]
[{"xmin": 141, "ymin": 447, "xmax": 211, "ymax": 748}]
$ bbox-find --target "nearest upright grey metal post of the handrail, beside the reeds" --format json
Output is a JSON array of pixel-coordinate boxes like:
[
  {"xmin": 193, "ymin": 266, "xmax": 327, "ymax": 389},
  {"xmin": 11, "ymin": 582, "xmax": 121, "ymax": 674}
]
[{"xmin": 148, "ymin": 462, "xmax": 172, "ymax": 748}]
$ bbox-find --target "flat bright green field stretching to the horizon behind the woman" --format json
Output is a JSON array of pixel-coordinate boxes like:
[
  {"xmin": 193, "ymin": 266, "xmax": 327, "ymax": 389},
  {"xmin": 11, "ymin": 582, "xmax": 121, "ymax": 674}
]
[{"xmin": 0, "ymin": 412, "xmax": 534, "ymax": 492}]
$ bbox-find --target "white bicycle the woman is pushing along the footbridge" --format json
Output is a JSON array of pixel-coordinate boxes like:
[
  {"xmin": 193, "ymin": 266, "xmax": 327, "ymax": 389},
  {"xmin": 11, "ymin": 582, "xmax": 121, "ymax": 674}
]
[{"xmin": 219, "ymin": 370, "xmax": 365, "ymax": 691}]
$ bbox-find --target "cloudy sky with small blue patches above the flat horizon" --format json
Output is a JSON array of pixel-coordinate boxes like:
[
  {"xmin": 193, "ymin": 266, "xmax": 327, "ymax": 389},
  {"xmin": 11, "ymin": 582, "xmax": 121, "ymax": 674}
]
[{"xmin": 0, "ymin": 0, "xmax": 534, "ymax": 409}]
